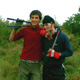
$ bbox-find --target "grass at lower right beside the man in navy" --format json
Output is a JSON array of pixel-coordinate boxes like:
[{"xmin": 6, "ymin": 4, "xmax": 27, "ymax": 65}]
[{"xmin": 64, "ymin": 51, "xmax": 80, "ymax": 80}]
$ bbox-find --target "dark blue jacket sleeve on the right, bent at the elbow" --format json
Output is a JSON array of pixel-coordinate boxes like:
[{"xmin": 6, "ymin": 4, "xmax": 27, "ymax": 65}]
[{"xmin": 61, "ymin": 34, "xmax": 73, "ymax": 57}]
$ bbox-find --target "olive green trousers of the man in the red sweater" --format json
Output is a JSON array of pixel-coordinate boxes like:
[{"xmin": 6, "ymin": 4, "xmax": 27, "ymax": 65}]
[{"xmin": 19, "ymin": 60, "xmax": 41, "ymax": 80}]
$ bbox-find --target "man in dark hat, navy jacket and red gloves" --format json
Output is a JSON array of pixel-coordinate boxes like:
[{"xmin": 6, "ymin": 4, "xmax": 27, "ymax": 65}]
[{"xmin": 40, "ymin": 15, "xmax": 73, "ymax": 80}]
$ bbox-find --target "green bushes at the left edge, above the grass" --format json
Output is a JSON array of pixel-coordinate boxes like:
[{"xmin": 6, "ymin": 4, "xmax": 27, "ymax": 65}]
[{"xmin": 0, "ymin": 17, "xmax": 13, "ymax": 47}]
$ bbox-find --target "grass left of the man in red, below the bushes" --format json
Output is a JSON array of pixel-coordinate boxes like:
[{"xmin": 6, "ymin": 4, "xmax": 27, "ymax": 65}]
[{"xmin": 0, "ymin": 41, "xmax": 22, "ymax": 80}]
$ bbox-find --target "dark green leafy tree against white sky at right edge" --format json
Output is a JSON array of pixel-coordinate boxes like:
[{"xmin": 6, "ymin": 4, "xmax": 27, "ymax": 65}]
[{"xmin": 63, "ymin": 13, "xmax": 80, "ymax": 35}]
